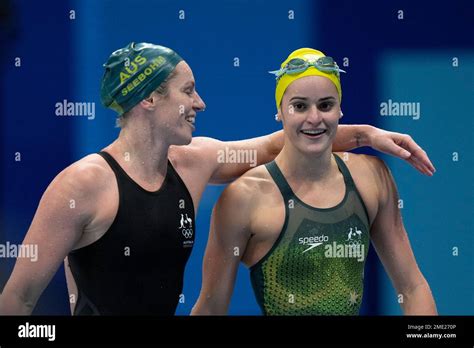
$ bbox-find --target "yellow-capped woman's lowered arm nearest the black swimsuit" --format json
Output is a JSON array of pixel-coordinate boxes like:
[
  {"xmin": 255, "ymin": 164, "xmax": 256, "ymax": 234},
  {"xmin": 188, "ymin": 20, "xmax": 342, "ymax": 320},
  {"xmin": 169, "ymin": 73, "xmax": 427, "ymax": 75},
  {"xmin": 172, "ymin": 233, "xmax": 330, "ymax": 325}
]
[{"xmin": 191, "ymin": 178, "xmax": 256, "ymax": 315}]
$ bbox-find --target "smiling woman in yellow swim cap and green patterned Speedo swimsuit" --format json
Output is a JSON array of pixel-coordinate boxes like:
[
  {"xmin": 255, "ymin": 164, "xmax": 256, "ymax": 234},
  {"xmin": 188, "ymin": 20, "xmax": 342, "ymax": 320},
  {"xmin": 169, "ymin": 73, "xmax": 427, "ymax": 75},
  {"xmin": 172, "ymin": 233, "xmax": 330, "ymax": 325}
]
[{"xmin": 192, "ymin": 48, "xmax": 436, "ymax": 315}]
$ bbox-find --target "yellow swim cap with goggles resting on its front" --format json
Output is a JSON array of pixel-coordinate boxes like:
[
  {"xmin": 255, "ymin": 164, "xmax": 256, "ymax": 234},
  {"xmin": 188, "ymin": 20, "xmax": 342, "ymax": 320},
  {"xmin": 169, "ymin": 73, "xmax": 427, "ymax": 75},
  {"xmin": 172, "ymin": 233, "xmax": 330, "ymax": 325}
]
[{"xmin": 271, "ymin": 48, "xmax": 345, "ymax": 109}]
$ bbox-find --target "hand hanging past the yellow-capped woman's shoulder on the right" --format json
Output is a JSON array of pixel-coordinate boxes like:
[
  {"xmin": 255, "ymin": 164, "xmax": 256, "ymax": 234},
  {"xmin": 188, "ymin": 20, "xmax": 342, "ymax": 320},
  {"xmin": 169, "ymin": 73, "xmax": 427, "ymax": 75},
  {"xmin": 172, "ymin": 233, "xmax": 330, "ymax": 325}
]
[{"xmin": 367, "ymin": 127, "xmax": 436, "ymax": 176}]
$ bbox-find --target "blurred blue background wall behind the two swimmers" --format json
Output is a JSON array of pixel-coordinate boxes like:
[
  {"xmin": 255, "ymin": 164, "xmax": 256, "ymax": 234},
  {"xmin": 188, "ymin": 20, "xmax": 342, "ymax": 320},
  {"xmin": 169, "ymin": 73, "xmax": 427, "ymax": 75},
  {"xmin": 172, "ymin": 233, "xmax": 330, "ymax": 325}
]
[{"xmin": 0, "ymin": 0, "xmax": 474, "ymax": 315}]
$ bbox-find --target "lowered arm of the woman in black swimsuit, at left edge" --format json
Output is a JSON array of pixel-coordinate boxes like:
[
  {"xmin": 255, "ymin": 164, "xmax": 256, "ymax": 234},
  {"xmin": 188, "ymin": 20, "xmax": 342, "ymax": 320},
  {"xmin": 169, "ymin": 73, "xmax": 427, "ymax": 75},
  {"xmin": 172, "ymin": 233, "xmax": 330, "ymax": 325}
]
[{"xmin": 0, "ymin": 165, "xmax": 97, "ymax": 315}]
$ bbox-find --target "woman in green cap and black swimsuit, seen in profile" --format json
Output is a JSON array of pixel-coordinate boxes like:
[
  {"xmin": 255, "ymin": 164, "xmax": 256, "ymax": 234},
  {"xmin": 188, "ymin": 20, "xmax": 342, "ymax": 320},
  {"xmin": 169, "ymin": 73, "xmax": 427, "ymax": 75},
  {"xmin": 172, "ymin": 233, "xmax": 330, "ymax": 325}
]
[{"xmin": 0, "ymin": 43, "xmax": 434, "ymax": 315}]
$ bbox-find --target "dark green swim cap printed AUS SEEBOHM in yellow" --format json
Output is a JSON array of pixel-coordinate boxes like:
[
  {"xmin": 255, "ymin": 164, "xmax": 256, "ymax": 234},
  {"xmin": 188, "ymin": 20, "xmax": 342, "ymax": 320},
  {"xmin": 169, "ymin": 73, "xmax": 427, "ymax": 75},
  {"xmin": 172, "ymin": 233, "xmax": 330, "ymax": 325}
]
[{"xmin": 100, "ymin": 42, "xmax": 183, "ymax": 115}]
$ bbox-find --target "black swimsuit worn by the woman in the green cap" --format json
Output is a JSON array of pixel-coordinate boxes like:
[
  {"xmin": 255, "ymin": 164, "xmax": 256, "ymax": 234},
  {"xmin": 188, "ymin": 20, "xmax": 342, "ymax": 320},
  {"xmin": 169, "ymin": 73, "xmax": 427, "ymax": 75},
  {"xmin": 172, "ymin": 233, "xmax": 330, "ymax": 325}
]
[{"xmin": 68, "ymin": 152, "xmax": 195, "ymax": 315}]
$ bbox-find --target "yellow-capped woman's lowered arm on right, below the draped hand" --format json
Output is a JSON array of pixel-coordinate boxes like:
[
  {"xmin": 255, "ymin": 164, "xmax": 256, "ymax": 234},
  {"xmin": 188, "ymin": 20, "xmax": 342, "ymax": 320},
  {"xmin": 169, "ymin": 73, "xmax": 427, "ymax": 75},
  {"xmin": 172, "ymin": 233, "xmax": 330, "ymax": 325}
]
[{"xmin": 370, "ymin": 157, "xmax": 437, "ymax": 315}]
